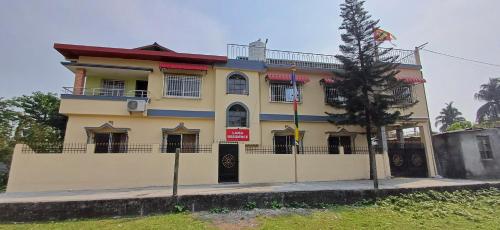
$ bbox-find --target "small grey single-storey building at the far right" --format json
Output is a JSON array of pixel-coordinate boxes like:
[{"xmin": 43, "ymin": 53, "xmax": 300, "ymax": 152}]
[{"xmin": 432, "ymin": 128, "xmax": 500, "ymax": 178}]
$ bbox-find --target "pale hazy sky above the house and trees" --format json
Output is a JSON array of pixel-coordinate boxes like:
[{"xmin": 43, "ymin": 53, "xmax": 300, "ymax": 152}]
[{"xmin": 0, "ymin": 0, "xmax": 500, "ymax": 127}]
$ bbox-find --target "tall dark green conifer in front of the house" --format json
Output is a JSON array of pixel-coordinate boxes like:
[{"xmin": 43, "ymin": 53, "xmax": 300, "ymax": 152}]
[{"xmin": 327, "ymin": 0, "xmax": 411, "ymax": 188}]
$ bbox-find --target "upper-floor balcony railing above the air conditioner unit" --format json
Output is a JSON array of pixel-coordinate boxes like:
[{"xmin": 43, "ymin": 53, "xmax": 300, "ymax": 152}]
[{"xmin": 62, "ymin": 87, "xmax": 149, "ymax": 98}]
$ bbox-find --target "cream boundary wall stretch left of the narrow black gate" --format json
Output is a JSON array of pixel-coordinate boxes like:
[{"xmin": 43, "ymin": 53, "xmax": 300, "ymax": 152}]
[{"xmin": 7, "ymin": 145, "xmax": 218, "ymax": 192}]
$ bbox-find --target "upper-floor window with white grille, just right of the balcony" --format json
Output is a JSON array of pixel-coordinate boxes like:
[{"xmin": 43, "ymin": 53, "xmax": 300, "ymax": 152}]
[{"xmin": 165, "ymin": 75, "xmax": 201, "ymax": 98}]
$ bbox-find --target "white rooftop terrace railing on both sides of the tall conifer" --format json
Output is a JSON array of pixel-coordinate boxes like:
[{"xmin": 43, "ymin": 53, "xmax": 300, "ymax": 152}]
[{"xmin": 227, "ymin": 44, "xmax": 417, "ymax": 69}]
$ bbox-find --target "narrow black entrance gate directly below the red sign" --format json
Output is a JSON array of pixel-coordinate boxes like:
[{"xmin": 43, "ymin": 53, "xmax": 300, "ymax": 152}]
[{"xmin": 219, "ymin": 144, "xmax": 238, "ymax": 183}]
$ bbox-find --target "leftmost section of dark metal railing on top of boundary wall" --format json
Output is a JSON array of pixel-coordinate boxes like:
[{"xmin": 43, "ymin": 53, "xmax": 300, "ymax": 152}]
[{"xmin": 21, "ymin": 142, "xmax": 87, "ymax": 153}]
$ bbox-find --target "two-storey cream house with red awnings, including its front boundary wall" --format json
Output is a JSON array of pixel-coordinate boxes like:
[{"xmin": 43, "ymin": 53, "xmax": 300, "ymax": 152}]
[{"xmin": 9, "ymin": 40, "xmax": 435, "ymax": 191}]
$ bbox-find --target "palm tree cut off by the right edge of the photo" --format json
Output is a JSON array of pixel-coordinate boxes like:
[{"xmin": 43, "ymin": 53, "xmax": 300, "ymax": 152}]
[{"xmin": 474, "ymin": 78, "xmax": 500, "ymax": 123}]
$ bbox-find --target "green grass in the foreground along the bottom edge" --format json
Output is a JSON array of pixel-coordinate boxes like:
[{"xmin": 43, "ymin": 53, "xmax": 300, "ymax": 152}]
[{"xmin": 0, "ymin": 189, "xmax": 500, "ymax": 229}]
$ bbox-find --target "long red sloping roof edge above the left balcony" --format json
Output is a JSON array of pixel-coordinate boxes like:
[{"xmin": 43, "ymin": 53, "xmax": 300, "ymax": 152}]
[{"xmin": 54, "ymin": 43, "xmax": 227, "ymax": 64}]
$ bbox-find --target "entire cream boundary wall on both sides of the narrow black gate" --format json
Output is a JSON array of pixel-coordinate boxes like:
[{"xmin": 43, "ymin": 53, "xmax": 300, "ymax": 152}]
[{"xmin": 7, "ymin": 144, "xmax": 390, "ymax": 192}]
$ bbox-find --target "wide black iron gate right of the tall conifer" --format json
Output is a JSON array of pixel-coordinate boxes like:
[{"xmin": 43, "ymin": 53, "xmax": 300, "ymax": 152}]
[{"xmin": 388, "ymin": 143, "xmax": 427, "ymax": 177}]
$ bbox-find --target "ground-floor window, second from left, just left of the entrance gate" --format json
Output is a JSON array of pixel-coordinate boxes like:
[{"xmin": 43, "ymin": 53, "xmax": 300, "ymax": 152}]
[{"xmin": 161, "ymin": 134, "xmax": 198, "ymax": 153}]
